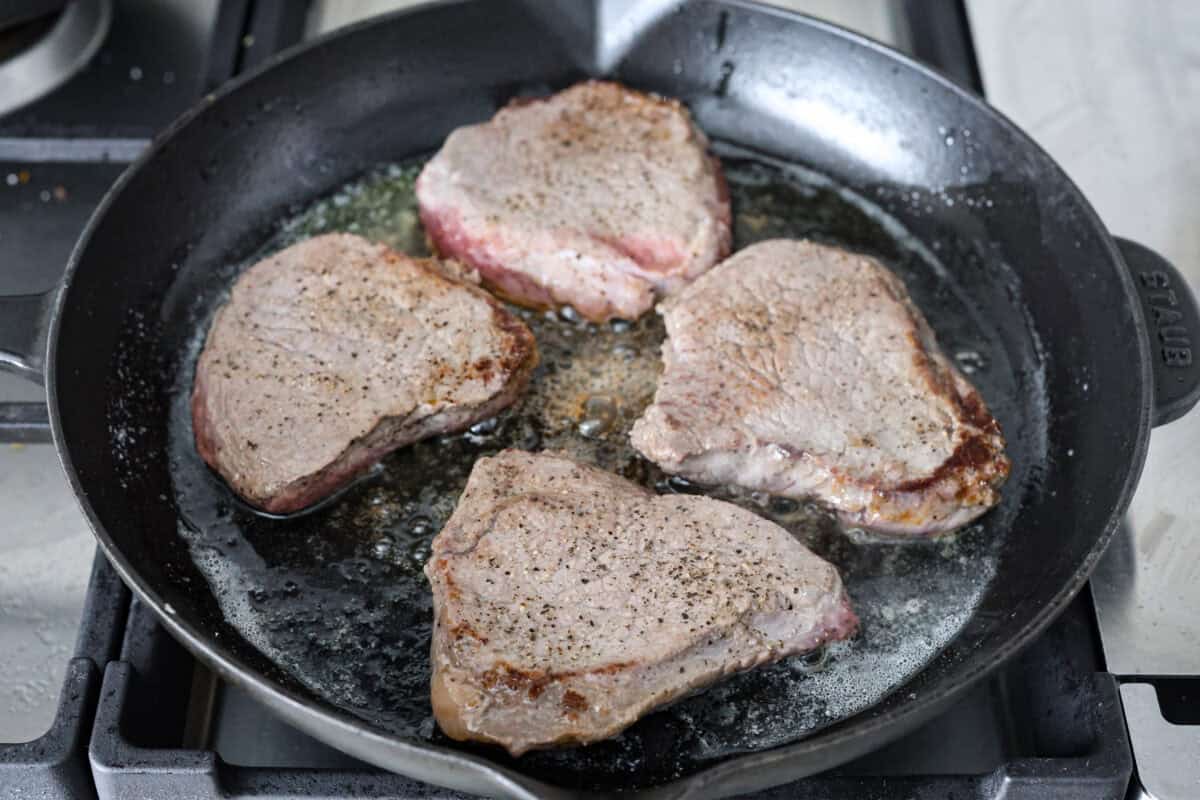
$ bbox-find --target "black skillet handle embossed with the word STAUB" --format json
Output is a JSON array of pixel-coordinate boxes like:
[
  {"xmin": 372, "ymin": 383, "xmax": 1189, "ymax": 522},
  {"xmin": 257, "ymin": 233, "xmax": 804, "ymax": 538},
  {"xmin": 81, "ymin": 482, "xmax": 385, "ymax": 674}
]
[{"xmin": 1115, "ymin": 236, "xmax": 1200, "ymax": 427}]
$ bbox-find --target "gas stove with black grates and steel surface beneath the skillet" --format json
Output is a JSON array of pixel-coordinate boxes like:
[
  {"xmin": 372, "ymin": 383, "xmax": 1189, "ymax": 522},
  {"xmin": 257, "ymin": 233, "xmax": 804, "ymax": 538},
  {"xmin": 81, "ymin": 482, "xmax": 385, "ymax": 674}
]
[{"xmin": 0, "ymin": 0, "xmax": 1200, "ymax": 800}]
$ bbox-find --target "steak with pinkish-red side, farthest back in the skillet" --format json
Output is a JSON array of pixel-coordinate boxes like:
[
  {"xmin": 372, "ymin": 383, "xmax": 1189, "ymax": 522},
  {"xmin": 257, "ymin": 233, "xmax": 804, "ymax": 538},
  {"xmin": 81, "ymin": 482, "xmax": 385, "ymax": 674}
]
[{"xmin": 416, "ymin": 80, "xmax": 731, "ymax": 321}]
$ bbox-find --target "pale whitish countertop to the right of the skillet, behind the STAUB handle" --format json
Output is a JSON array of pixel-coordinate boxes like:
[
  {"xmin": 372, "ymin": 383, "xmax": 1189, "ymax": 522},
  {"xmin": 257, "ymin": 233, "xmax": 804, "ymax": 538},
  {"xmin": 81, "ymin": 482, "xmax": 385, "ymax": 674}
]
[{"xmin": 967, "ymin": 0, "xmax": 1200, "ymax": 675}]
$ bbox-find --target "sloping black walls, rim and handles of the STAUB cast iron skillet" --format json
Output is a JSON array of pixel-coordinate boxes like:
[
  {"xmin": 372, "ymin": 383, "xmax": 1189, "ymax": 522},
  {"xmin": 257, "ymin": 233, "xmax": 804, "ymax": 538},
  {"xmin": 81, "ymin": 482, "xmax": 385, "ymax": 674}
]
[{"xmin": 0, "ymin": 0, "xmax": 1200, "ymax": 796}]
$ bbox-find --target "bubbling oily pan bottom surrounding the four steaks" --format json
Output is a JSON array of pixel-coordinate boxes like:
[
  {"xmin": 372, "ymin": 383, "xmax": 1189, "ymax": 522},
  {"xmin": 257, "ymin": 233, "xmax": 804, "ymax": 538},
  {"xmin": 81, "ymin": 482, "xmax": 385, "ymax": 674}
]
[{"xmin": 159, "ymin": 148, "xmax": 1044, "ymax": 789}]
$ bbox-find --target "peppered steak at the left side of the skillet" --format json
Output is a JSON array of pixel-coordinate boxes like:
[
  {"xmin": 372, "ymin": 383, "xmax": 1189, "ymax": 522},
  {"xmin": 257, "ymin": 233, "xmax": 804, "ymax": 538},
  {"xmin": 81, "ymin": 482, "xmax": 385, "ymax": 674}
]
[{"xmin": 192, "ymin": 234, "xmax": 538, "ymax": 513}]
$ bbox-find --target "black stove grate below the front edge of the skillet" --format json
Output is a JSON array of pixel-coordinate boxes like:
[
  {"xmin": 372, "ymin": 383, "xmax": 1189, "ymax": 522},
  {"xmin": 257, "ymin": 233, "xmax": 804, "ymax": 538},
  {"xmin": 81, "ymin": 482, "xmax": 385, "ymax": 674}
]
[{"xmin": 82, "ymin": 587, "xmax": 1132, "ymax": 800}]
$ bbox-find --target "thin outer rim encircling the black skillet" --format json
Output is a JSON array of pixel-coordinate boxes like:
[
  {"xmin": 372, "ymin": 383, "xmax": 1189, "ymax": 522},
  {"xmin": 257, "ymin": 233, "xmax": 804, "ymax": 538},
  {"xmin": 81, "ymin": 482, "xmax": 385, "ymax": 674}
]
[{"xmin": 46, "ymin": 0, "xmax": 1153, "ymax": 798}]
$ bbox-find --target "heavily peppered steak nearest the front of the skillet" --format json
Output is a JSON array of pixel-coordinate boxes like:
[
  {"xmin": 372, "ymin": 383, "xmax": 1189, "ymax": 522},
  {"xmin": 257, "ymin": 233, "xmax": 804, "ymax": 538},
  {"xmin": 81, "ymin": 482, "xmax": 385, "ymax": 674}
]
[{"xmin": 425, "ymin": 450, "xmax": 858, "ymax": 756}]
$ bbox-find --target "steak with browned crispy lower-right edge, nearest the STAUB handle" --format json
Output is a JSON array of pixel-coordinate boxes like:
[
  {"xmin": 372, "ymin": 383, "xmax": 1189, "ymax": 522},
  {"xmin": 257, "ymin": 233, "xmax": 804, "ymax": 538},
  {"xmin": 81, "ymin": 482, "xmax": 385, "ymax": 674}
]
[{"xmin": 631, "ymin": 240, "xmax": 1009, "ymax": 535}]
